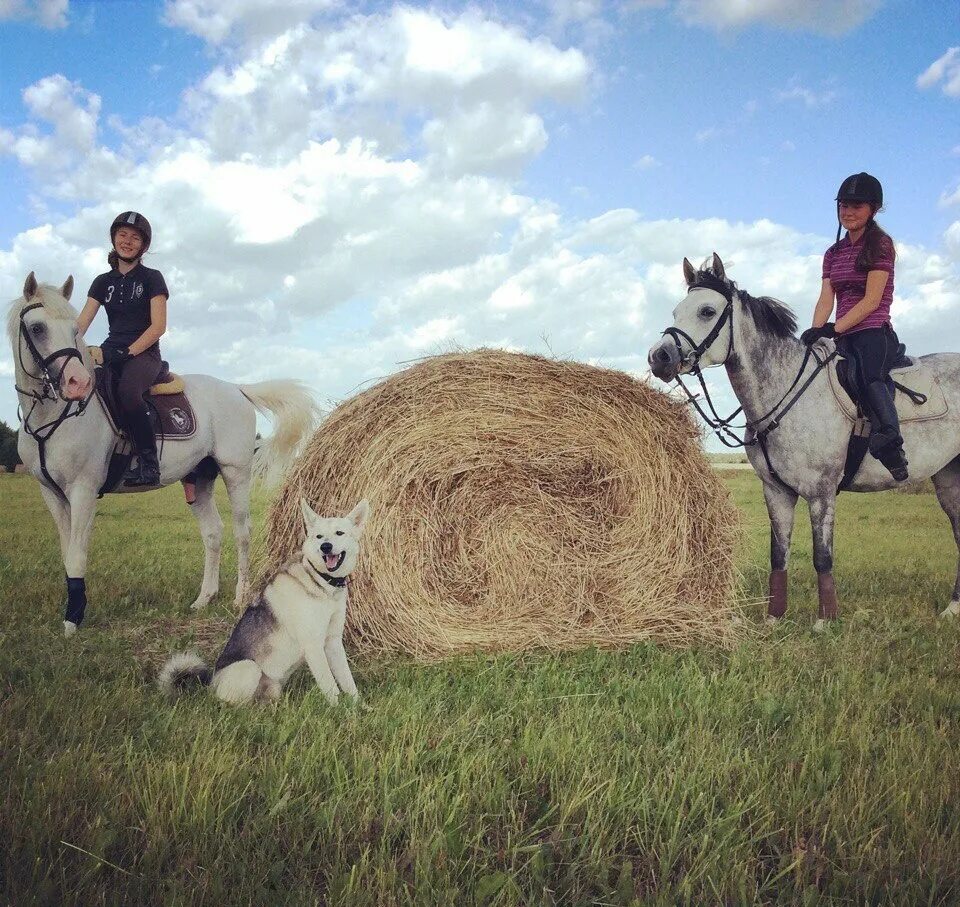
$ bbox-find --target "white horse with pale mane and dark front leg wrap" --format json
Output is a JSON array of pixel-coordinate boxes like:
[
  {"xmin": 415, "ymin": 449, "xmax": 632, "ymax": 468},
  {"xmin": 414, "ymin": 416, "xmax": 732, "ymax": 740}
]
[{"xmin": 7, "ymin": 272, "xmax": 317, "ymax": 636}]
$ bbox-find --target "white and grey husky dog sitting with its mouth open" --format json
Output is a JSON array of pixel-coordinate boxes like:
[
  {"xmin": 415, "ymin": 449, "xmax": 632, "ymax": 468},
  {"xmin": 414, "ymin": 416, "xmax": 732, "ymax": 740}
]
[{"xmin": 157, "ymin": 500, "xmax": 370, "ymax": 705}]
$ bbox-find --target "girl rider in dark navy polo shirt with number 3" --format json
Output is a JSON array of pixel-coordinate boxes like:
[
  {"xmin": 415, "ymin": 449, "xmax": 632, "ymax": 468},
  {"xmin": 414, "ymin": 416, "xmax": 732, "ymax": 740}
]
[{"xmin": 77, "ymin": 211, "xmax": 170, "ymax": 486}]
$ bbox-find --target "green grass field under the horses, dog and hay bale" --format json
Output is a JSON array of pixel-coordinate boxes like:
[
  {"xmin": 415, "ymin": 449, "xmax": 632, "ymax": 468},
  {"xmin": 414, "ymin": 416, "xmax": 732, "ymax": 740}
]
[{"xmin": 0, "ymin": 472, "xmax": 960, "ymax": 907}]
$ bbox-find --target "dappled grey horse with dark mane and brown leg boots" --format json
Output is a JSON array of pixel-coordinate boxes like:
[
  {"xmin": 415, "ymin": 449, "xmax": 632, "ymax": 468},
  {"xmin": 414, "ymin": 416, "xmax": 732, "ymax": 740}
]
[{"xmin": 647, "ymin": 253, "xmax": 960, "ymax": 629}]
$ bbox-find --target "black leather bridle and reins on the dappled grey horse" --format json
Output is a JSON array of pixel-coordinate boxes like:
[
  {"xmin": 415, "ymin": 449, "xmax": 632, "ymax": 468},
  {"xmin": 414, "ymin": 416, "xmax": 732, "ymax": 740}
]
[{"xmin": 663, "ymin": 271, "xmax": 838, "ymax": 494}]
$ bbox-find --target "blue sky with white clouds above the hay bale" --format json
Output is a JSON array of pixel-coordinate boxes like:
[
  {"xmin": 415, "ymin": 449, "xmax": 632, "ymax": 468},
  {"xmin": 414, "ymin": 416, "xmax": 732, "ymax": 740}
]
[{"xmin": 0, "ymin": 0, "xmax": 960, "ymax": 446}]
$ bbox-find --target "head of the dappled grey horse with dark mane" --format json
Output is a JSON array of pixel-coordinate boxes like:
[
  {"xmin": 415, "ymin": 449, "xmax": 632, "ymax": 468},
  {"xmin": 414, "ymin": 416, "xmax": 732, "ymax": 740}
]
[{"xmin": 647, "ymin": 252, "xmax": 736, "ymax": 381}]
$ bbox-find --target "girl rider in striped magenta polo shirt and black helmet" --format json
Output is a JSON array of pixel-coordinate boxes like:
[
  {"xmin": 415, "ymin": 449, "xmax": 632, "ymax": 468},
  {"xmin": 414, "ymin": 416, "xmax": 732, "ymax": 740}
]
[{"xmin": 800, "ymin": 173, "xmax": 908, "ymax": 482}]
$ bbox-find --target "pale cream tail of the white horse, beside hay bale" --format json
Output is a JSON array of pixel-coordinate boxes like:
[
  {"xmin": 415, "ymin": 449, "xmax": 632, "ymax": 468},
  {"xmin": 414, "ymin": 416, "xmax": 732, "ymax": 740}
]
[{"xmin": 240, "ymin": 380, "xmax": 319, "ymax": 485}]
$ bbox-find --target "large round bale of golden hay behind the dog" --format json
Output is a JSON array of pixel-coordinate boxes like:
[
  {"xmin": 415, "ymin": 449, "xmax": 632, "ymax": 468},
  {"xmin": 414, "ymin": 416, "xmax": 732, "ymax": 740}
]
[{"xmin": 261, "ymin": 350, "xmax": 737, "ymax": 659}]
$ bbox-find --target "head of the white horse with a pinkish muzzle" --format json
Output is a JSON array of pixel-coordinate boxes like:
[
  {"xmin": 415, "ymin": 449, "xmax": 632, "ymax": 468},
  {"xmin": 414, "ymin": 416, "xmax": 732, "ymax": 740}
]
[{"xmin": 7, "ymin": 271, "xmax": 93, "ymax": 400}]
